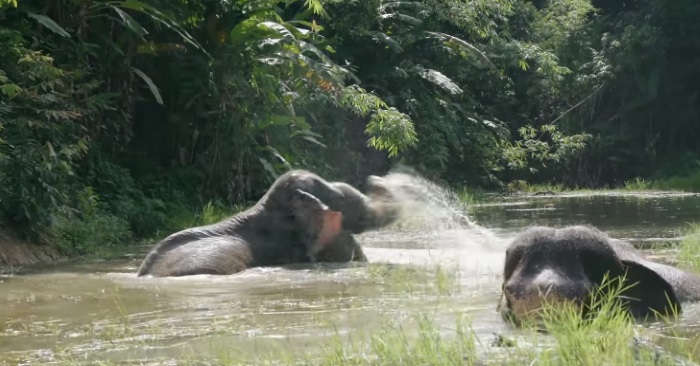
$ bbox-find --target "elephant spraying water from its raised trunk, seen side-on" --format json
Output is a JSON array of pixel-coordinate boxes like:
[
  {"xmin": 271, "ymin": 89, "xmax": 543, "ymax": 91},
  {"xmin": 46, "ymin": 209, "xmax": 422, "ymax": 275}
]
[{"xmin": 137, "ymin": 169, "xmax": 399, "ymax": 277}]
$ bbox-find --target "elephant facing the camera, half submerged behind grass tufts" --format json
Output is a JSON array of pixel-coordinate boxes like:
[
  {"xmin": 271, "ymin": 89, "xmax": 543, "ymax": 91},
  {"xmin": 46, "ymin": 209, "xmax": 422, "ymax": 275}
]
[{"xmin": 497, "ymin": 225, "xmax": 700, "ymax": 325}]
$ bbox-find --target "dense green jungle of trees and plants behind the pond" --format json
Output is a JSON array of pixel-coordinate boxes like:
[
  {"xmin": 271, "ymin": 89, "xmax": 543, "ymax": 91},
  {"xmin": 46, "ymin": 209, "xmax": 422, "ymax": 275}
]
[{"xmin": 0, "ymin": 0, "xmax": 700, "ymax": 254}]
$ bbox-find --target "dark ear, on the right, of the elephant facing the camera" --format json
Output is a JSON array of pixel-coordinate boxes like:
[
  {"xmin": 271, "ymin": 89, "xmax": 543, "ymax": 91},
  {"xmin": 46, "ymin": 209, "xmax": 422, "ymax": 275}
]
[{"xmin": 622, "ymin": 260, "xmax": 681, "ymax": 318}]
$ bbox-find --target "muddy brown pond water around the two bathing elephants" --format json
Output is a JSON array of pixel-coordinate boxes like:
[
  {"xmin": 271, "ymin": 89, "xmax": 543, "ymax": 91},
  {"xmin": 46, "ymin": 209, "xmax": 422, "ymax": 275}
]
[{"xmin": 0, "ymin": 187, "xmax": 700, "ymax": 365}]
